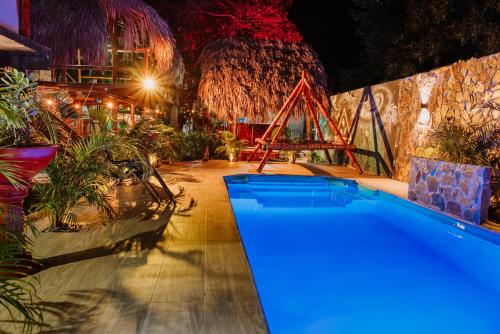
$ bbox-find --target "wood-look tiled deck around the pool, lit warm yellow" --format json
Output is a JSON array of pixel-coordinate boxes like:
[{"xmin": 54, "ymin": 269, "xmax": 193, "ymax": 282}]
[{"xmin": 0, "ymin": 161, "xmax": 426, "ymax": 333}]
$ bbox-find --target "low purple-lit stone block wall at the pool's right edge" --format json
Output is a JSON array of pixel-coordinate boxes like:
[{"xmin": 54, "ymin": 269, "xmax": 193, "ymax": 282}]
[{"xmin": 408, "ymin": 157, "xmax": 491, "ymax": 224}]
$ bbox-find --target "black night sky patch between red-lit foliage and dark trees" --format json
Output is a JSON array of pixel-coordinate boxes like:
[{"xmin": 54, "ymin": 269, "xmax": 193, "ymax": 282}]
[{"xmin": 289, "ymin": 0, "xmax": 362, "ymax": 87}]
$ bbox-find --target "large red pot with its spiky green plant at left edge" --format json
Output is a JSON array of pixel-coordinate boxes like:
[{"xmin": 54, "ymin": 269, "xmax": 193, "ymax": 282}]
[{"xmin": 0, "ymin": 68, "xmax": 57, "ymax": 230}]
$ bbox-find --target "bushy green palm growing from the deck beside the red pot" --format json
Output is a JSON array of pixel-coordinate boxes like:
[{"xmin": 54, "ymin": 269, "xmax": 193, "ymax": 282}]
[{"xmin": 34, "ymin": 133, "xmax": 147, "ymax": 230}]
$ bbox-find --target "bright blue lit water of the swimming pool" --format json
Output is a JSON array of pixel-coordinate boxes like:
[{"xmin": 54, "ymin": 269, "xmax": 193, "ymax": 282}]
[{"xmin": 225, "ymin": 175, "xmax": 500, "ymax": 334}]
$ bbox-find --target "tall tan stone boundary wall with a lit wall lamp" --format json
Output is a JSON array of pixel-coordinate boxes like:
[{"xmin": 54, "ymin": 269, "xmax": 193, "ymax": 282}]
[{"xmin": 331, "ymin": 53, "xmax": 500, "ymax": 181}]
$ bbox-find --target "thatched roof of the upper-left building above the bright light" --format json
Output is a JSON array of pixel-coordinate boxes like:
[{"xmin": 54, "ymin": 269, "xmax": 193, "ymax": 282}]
[{"xmin": 31, "ymin": 0, "xmax": 184, "ymax": 80}]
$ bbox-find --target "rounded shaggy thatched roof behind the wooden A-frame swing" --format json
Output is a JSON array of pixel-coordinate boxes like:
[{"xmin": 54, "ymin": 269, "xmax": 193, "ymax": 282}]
[{"xmin": 198, "ymin": 39, "xmax": 328, "ymax": 121}]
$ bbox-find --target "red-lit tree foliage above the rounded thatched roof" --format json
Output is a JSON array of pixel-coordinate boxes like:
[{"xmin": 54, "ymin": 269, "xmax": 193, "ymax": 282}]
[{"xmin": 152, "ymin": 0, "xmax": 302, "ymax": 57}]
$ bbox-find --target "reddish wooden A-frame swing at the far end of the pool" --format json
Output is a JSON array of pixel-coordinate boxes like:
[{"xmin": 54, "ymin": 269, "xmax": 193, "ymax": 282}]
[{"xmin": 248, "ymin": 72, "xmax": 363, "ymax": 174}]
